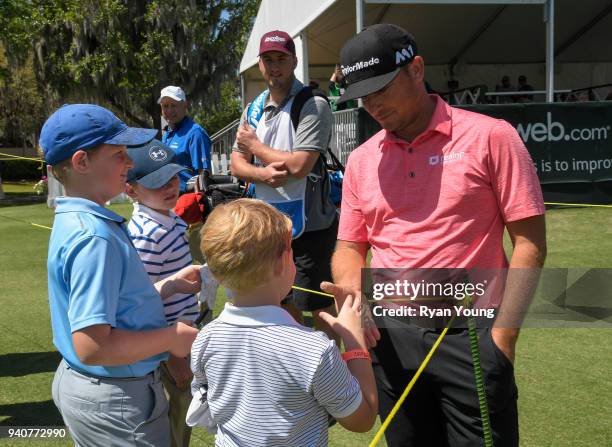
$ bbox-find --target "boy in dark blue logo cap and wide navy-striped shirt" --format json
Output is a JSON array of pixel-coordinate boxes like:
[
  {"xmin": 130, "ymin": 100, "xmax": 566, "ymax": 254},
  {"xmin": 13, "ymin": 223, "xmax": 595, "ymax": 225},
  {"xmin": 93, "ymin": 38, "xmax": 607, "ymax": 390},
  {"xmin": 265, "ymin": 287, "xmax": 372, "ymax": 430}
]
[{"xmin": 126, "ymin": 140, "xmax": 199, "ymax": 447}]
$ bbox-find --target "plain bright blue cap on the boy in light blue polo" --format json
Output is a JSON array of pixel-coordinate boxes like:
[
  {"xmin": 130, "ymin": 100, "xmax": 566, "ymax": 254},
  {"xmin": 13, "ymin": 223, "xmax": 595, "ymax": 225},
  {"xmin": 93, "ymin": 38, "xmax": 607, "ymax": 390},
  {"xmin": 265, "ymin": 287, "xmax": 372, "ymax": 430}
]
[{"xmin": 39, "ymin": 104, "xmax": 157, "ymax": 165}]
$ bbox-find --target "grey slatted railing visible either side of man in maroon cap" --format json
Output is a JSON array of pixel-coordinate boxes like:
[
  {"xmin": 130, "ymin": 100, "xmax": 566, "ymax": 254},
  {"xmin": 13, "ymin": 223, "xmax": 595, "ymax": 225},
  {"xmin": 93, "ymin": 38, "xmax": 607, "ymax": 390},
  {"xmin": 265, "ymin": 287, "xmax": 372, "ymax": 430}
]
[{"xmin": 210, "ymin": 109, "xmax": 359, "ymax": 174}]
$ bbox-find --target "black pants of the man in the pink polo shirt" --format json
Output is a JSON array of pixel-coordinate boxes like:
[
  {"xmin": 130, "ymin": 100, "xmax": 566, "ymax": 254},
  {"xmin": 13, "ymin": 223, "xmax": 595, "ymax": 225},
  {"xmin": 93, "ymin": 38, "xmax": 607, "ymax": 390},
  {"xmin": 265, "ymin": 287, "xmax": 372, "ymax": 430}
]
[{"xmin": 372, "ymin": 326, "xmax": 519, "ymax": 447}]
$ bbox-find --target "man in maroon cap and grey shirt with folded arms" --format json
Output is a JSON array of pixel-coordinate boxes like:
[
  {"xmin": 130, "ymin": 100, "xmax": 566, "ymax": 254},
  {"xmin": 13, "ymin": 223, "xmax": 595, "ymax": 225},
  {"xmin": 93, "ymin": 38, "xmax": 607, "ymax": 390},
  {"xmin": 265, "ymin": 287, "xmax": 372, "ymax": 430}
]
[{"xmin": 231, "ymin": 31, "xmax": 338, "ymax": 338}]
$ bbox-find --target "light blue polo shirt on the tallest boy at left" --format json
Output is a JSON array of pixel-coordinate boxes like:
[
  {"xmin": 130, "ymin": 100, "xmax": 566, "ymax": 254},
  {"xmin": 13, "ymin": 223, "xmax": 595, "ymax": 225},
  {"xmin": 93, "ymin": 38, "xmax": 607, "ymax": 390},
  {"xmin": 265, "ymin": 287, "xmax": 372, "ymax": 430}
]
[{"xmin": 47, "ymin": 197, "xmax": 167, "ymax": 377}]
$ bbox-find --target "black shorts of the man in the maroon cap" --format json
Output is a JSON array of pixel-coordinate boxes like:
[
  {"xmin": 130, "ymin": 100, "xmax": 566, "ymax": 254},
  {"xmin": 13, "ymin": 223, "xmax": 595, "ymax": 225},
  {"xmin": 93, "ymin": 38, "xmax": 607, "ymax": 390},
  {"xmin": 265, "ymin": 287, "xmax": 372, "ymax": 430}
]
[{"xmin": 288, "ymin": 219, "xmax": 338, "ymax": 311}]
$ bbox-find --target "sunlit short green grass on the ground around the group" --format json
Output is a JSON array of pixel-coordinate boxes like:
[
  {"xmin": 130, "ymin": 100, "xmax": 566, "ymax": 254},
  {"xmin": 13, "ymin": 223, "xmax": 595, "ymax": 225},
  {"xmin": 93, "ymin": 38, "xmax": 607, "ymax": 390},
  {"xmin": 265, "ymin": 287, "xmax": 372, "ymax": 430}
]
[{"xmin": 0, "ymin": 204, "xmax": 612, "ymax": 447}]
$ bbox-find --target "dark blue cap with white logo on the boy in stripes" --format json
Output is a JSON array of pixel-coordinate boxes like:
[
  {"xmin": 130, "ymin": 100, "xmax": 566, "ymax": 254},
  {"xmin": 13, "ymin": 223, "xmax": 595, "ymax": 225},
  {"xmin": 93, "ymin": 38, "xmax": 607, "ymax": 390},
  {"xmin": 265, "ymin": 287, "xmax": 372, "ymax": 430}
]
[{"xmin": 127, "ymin": 140, "xmax": 187, "ymax": 189}]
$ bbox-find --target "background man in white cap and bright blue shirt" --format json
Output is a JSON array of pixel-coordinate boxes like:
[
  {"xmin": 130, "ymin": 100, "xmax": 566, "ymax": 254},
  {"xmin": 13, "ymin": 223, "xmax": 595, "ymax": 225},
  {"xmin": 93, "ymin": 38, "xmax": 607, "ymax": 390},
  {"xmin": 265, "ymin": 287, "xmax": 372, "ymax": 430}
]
[{"xmin": 157, "ymin": 85, "xmax": 211, "ymax": 193}]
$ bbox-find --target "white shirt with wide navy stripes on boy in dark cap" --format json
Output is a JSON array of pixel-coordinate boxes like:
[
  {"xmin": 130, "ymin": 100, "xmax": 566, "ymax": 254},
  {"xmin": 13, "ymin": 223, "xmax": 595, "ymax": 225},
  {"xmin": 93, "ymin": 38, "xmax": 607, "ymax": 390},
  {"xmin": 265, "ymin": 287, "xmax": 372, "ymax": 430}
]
[{"xmin": 128, "ymin": 203, "xmax": 198, "ymax": 324}]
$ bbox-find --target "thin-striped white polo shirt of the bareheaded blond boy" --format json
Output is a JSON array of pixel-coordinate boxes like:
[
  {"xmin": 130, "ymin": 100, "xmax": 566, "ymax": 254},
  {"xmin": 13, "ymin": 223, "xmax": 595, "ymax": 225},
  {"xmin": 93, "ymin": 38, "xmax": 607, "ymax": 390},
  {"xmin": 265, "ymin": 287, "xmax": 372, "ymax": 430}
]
[{"xmin": 191, "ymin": 303, "xmax": 362, "ymax": 447}]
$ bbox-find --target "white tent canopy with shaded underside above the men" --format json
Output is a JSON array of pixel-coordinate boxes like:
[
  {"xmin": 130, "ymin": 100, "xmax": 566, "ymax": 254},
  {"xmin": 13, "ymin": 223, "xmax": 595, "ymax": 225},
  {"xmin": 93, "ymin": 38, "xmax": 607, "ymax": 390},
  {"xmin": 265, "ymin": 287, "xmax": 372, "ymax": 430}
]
[{"xmin": 240, "ymin": 0, "xmax": 612, "ymax": 100}]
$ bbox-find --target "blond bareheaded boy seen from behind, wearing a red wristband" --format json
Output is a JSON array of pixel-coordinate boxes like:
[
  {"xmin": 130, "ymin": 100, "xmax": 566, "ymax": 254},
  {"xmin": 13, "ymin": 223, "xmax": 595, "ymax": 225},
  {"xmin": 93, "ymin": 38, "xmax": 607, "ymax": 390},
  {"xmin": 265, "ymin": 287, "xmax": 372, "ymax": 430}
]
[{"xmin": 188, "ymin": 199, "xmax": 378, "ymax": 447}]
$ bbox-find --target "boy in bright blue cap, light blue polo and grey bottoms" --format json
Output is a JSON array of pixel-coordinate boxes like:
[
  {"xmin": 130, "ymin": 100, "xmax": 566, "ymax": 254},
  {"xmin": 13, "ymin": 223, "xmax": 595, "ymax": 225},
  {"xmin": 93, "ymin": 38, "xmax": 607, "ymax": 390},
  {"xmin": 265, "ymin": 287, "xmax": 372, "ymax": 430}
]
[{"xmin": 40, "ymin": 104, "xmax": 199, "ymax": 446}]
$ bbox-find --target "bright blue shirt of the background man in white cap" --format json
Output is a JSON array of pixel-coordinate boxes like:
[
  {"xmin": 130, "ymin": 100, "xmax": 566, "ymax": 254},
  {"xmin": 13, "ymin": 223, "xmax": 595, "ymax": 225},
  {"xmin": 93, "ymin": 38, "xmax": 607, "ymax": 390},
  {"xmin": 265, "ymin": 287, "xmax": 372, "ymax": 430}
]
[{"xmin": 162, "ymin": 116, "xmax": 211, "ymax": 192}]
